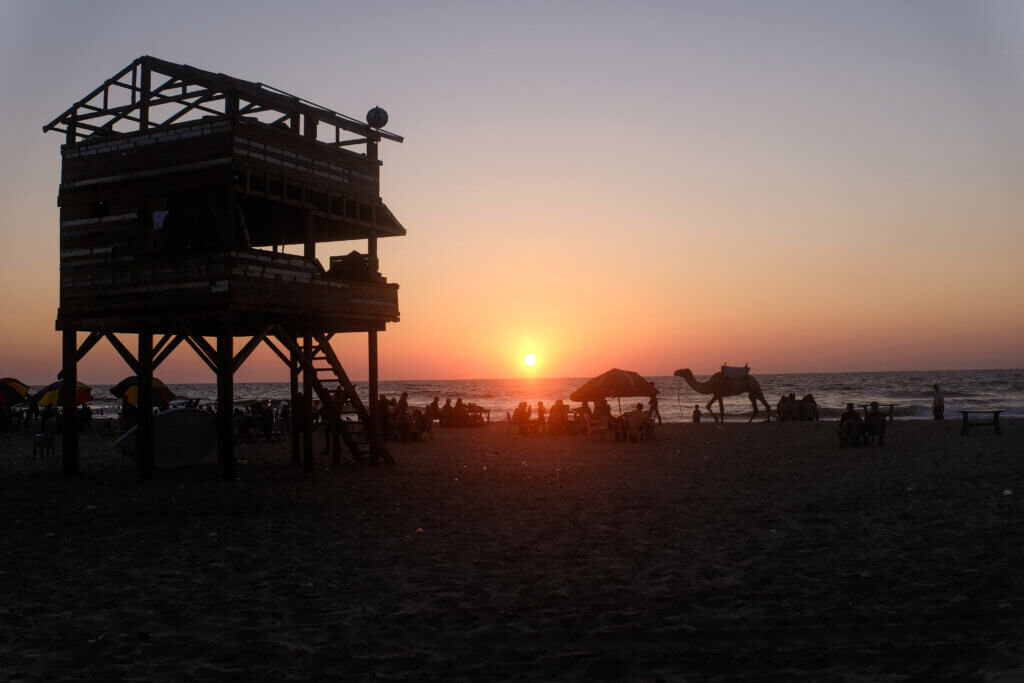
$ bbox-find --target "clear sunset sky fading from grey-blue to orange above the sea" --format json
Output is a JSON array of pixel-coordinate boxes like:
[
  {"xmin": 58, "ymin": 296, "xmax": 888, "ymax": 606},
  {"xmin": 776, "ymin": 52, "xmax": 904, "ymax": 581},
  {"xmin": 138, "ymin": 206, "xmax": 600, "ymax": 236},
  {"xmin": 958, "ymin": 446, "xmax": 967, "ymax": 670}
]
[{"xmin": 0, "ymin": 0, "xmax": 1024, "ymax": 384}]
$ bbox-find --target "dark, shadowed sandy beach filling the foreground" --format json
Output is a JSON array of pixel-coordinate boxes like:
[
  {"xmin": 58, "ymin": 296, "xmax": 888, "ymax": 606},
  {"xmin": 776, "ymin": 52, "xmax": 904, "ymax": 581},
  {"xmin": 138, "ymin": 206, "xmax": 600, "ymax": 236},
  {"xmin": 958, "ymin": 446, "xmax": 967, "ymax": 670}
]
[{"xmin": 0, "ymin": 420, "xmax": 1024, "ymax": 681}]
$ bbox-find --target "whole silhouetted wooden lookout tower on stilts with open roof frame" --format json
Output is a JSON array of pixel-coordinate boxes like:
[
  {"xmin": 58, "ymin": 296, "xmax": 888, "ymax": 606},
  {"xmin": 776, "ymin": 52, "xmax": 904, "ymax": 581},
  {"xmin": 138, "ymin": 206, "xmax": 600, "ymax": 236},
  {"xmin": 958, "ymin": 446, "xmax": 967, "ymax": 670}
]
[{"xmin": 43, "ymin": 56, "xmax": 406, "ymax": 479}]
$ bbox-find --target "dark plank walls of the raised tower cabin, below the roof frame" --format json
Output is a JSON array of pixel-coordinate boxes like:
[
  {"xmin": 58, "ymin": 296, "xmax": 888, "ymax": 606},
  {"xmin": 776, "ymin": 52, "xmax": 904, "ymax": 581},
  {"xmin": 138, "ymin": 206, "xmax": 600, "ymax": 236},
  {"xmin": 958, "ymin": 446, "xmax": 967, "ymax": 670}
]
[{"xmin": 58, "ymin": 119, "xmax": 398, "ymax": 329}]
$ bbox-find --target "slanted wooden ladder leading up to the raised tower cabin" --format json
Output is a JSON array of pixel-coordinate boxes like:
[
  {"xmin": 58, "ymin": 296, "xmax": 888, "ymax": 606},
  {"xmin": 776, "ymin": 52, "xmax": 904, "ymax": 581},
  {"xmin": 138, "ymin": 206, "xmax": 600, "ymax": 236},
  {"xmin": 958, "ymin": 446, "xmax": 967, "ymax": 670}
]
[{"xmin": 275, "ymin": 326, "xmax": 394, "ymax": 465}]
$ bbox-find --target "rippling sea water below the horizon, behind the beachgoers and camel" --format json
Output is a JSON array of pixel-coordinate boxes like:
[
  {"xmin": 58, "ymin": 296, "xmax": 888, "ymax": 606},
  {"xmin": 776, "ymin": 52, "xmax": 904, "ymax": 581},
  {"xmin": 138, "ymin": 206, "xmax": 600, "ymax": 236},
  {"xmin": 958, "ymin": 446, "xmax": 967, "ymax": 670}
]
[{"xmin": 49, "ymin": 369, "xmax": 1024, "ymax": 422}]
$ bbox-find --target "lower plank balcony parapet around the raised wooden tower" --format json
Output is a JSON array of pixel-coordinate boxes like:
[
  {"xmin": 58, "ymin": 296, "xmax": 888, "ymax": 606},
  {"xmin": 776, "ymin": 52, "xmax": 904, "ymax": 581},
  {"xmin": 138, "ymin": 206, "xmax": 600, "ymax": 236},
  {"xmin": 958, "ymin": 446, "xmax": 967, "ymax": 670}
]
[{"xmin": 57, "ymin": 249, "xmax": 398, "ymax": 335}]
